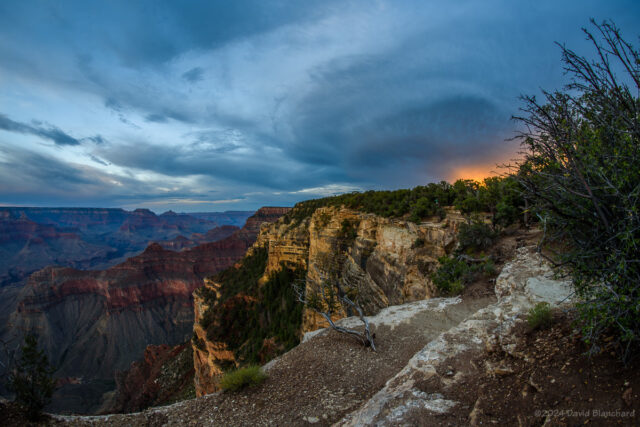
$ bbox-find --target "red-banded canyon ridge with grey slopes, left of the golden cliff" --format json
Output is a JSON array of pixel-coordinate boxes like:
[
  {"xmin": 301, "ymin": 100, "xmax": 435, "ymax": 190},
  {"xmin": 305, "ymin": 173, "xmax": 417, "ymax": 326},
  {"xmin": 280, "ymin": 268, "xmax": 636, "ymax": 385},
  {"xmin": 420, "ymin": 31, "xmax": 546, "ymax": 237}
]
[{"xmin": 5, "ymin": 208, "xmax": 288, "ymax": 411}]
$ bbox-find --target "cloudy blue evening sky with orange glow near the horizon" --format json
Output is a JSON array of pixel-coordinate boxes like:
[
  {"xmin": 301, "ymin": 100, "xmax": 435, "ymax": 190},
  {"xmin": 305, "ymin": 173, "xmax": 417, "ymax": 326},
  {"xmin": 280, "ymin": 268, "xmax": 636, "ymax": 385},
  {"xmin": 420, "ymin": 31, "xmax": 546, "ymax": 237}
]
[{"xmin": 0, "ymin": 0, "xmax": 640, "ymax": 213}]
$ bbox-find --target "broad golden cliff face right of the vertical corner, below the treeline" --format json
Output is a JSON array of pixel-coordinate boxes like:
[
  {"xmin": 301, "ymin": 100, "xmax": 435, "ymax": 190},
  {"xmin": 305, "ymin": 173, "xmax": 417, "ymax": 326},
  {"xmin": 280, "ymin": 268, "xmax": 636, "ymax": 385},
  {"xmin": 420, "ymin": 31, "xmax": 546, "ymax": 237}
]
[{"xmin": 300, "ymin": 207, "xmax": 464, "ymax": 332}]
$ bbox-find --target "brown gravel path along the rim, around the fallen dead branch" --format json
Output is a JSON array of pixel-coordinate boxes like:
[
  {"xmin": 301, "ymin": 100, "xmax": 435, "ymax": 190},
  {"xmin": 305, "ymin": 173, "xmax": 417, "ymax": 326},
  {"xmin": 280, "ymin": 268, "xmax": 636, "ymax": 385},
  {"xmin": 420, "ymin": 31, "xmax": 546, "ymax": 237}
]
[{"xmin": 55, "ymin": 297, "xmax": 494, "ymax": 426}]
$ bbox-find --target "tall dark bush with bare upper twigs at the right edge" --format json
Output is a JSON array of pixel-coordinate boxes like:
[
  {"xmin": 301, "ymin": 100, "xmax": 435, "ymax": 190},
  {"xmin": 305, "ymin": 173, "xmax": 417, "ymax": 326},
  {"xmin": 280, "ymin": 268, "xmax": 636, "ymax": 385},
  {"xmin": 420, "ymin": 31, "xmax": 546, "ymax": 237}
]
[{"xmin": 516, "ymin": 21, "xmax": 640, "ymax": 357}]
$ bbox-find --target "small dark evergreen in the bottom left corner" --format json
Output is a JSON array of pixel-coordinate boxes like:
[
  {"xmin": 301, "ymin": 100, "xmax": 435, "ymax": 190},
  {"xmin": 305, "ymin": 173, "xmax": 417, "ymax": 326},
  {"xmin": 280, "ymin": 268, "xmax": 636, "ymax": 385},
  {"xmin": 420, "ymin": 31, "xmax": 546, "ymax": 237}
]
[{"xmin": 9, "ymin": 334, "xmax": 55, "ymax": 421}]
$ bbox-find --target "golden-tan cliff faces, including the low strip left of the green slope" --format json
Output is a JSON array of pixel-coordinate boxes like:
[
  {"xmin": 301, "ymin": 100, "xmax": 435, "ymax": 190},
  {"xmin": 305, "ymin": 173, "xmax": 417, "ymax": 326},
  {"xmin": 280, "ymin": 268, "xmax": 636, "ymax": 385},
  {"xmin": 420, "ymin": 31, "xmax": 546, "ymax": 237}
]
[{"xmin": 193, "ymin": 207, "xmax": 464, "ymax": 396}]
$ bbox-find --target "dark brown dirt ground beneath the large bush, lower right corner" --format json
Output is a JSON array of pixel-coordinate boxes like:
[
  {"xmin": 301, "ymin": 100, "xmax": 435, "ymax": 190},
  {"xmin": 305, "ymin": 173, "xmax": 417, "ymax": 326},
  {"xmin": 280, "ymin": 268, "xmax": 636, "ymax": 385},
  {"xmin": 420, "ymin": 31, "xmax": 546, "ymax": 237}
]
[{"xmin": 415, "ymin": 311, "xmax": 640, "ymax": 426}]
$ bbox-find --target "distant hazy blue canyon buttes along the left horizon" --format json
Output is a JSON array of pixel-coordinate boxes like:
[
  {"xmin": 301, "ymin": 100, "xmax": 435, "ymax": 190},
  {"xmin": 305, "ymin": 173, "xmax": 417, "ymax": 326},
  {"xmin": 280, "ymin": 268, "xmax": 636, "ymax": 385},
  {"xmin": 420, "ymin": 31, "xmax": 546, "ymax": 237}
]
[{"xmin": 0, "ymin": 207, "xmax": 252, "ymax": 288}]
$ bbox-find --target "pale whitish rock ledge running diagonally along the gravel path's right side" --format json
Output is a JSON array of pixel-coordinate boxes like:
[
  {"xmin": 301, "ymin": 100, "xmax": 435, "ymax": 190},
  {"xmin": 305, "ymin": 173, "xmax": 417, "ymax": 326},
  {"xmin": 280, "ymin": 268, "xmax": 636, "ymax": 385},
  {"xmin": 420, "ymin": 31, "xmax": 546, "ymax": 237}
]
[{"xmin": 338, "ymin": 247, "xmax": 572, "ymax": 426}]
